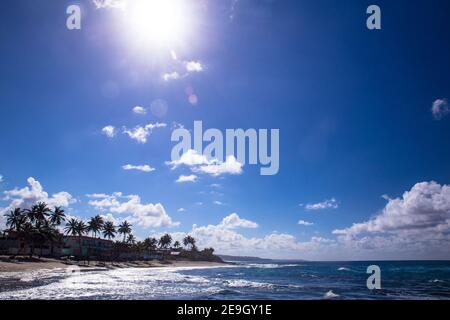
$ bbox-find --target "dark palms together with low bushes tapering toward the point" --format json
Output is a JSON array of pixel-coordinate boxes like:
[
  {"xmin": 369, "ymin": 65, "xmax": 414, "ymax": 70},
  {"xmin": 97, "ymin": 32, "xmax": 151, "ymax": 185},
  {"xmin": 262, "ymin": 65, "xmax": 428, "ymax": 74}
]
[{"xmin": 0, "ymin": 202, "xmax": 220, "ymax": 261}]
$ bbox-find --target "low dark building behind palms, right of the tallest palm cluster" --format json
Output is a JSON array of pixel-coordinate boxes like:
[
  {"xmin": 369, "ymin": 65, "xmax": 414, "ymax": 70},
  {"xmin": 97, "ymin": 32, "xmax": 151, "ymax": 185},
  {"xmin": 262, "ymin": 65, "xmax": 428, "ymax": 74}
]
[{"xmin": 62, "ymin": 236, "xmax": 114, "ymax": 259}]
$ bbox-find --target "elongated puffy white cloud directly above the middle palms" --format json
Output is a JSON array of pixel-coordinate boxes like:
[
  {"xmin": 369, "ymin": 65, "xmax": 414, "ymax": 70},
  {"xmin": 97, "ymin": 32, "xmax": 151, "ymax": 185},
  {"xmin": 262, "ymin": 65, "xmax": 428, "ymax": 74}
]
[{"xmin": 88, "ymin": 192, "xmax": 179, "ymax": 228}]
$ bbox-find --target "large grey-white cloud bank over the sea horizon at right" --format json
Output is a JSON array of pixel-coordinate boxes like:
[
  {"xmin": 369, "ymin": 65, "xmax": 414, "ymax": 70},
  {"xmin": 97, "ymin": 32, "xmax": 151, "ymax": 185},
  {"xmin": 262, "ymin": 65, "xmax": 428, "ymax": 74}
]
[{"xmin": 333, "ymin": 181, "xmax": 450, "ymax": 259}]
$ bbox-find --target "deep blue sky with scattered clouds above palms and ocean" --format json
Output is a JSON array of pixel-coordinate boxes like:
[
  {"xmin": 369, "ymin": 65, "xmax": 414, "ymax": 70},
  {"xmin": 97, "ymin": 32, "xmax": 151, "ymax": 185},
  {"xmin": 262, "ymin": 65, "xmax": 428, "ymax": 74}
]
[{"xmin": 0, "ymin": 0, "xmax": 450, "ymax": 259}]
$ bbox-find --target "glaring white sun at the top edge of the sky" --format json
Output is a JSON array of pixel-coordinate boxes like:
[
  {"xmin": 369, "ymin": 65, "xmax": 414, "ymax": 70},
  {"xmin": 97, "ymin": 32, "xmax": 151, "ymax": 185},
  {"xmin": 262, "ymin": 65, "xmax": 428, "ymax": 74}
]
[{"xmin": 126, "ymin": 0, "xmax": 189, "ymax": 46}]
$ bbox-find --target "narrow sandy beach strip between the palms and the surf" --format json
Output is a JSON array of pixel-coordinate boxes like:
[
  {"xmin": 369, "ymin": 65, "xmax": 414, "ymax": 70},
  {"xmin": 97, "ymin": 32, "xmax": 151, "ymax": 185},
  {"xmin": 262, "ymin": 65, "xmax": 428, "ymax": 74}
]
[{"xmin": 0, "ymin": 257, "xmax": 232, "ymax": 275}]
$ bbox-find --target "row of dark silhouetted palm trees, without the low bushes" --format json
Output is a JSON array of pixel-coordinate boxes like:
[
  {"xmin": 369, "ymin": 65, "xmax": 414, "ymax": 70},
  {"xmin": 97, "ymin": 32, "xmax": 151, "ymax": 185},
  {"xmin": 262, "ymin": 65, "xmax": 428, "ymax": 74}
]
[{"xmin": 5, "ymin": 202, "xmax": 197, "ymax": 257}]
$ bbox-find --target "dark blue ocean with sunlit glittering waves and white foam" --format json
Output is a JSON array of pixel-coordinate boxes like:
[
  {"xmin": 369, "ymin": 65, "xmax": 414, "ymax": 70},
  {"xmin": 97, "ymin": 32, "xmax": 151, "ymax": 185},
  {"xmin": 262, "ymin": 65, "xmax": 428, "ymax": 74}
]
[{"xmin": 0, "ymin": 261, "xmax": 450, "ymax": 300}]
